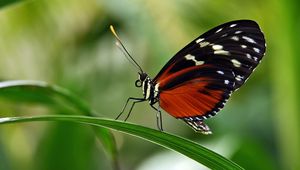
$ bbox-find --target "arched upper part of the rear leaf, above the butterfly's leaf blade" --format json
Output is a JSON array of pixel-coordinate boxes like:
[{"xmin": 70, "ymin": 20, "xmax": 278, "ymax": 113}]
[{"xmin": 0, "ymin": 80, "xmax": 94, "ymax": 116}]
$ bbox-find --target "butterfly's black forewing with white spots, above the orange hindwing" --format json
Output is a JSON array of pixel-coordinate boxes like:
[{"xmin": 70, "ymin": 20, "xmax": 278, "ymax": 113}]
[{"xmin": 154, "ymin": 20, "xmax": 266, "ymax": 90}]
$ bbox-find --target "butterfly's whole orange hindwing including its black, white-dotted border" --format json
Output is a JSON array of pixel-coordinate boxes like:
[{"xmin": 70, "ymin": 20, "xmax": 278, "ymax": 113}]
[{"xmin": 159, "ymin": 65, "xmax": 234, "ymax": 119}]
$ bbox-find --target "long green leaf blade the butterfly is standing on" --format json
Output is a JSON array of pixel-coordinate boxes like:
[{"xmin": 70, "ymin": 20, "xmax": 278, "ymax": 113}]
[{"xmin": 0, "ymin": 115, "xmax": 243, "ymax": 169}]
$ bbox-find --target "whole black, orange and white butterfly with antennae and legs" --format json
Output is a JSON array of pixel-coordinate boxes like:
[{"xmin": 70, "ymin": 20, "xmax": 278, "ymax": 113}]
[{"xmin": 111, "ymin": 20, "xmax": 266, "ymax": 134}]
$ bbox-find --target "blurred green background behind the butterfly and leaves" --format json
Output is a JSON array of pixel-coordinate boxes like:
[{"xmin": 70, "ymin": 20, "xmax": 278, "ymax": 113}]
[{"xmin": 0, "ymin": 0, "xmax": 300, "ymax": 170}]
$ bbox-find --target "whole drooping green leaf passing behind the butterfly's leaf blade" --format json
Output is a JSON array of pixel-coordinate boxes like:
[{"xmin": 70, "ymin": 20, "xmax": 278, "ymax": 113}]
[{"xmin": 0, "ymin": 80, "xmax": 118, "ymax": 169}]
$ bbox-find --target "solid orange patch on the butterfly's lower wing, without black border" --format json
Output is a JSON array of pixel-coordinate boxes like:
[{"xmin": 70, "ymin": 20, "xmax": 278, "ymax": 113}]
[{"xmin": 160, "ymin": 81, "xmax": 225, "ymax": 118}]
